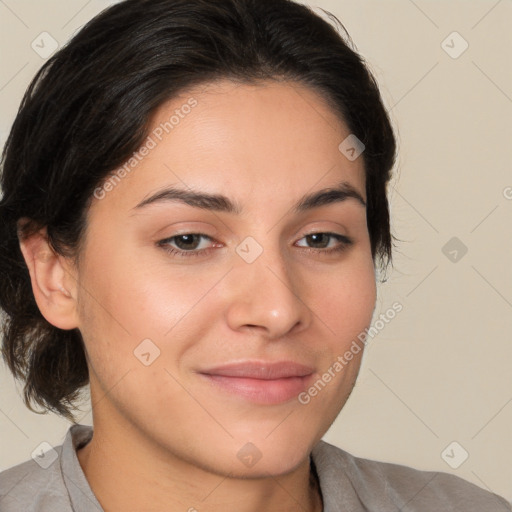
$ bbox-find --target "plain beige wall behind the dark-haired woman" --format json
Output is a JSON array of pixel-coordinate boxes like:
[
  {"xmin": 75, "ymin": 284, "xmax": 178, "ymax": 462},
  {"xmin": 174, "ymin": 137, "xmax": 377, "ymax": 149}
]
[{"xmin": 0, "ymin": 0, "xmax": 512, "ymax": 500}]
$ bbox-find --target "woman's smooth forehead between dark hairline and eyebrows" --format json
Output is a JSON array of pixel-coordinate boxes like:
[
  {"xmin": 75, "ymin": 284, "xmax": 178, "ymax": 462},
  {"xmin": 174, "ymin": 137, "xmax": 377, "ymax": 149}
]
[{"xmin": 90, "ymin": 80, "xmax": 365, "ymax": 215}]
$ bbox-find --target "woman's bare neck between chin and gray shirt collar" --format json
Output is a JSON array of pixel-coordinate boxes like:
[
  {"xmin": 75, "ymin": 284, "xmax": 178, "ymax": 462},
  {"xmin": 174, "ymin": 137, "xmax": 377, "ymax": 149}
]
[{"xmin": 77, "ymin": 421, "xmax": 322, "ymax": 512}]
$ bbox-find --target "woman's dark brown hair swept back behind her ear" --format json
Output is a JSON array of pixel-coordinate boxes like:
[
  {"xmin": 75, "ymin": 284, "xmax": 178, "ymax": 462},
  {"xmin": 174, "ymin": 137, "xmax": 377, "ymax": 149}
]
[{"xmin": 0, "ymin": 0, "xmax": 396, "ymax": 421}]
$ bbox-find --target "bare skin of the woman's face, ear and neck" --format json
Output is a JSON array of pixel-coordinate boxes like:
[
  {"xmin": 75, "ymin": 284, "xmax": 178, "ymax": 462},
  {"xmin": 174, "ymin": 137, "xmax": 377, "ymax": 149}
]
[{"xmin": 21, "ymin": 81, "xmax": 376, "ymax": 512}]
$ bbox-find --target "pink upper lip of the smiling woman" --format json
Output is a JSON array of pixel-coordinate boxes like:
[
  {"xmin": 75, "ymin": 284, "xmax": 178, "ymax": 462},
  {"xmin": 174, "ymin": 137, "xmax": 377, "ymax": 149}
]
[{"xmin": 199, "ymin": 361, "xmax": 314, "ymax": 380}]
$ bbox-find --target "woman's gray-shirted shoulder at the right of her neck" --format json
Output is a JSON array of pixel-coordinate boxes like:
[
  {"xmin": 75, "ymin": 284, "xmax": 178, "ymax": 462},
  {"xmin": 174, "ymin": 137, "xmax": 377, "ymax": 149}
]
[{"xmin": 312, "ymin": 441, "xmax": 512, "ymax": 512}]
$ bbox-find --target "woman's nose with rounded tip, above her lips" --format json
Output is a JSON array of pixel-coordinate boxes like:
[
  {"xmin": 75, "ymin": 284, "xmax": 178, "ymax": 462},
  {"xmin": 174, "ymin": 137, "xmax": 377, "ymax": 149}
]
[{"xmin": 226, "ymin": 244, "xmax": 313, "ymax": 339}]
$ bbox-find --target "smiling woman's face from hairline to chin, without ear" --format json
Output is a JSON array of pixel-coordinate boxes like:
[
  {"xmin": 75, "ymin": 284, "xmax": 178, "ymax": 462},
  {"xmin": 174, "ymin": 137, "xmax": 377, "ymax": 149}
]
[{"xmin": 76, "ymin": 81, "xmax": 375, "ymax": 476}]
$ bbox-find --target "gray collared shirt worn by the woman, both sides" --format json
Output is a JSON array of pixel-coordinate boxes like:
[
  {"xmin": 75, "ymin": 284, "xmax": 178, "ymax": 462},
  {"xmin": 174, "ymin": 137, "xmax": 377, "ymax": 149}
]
[{"xmin": 0, "ymin": 424, "xmax": 512, "ymax": 512}]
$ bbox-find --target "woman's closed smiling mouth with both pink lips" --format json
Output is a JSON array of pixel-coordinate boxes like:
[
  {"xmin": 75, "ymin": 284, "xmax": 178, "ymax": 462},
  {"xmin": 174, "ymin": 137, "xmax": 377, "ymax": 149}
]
[{"xmin": 199, "ymin": 361, "xmax": 314, "ymax": 405}]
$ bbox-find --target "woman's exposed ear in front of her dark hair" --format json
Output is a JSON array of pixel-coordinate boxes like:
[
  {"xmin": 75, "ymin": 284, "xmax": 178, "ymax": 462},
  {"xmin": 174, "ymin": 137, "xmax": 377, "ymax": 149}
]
[{"xmin": 18, "ymin": 219, "xmax": 78, "ymax": 329}]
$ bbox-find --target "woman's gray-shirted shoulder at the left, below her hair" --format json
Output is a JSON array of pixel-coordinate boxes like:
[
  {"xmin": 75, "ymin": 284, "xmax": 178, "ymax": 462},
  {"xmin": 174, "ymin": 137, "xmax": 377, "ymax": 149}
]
[{"xmin": 0, "ymin": 446, "xmax": 71, "ymax": 512}]
